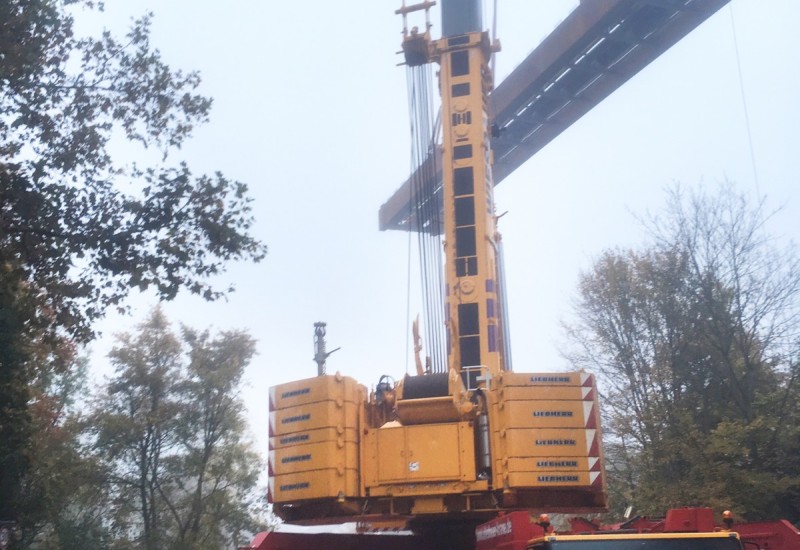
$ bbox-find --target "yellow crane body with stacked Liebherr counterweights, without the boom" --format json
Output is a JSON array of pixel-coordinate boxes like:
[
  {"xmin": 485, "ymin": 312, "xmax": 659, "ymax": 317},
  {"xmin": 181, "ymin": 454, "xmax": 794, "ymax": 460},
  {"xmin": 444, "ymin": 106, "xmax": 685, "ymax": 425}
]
[{"xmin": 269, "ymin": 372, "xmax": 606, "ymax": 520}]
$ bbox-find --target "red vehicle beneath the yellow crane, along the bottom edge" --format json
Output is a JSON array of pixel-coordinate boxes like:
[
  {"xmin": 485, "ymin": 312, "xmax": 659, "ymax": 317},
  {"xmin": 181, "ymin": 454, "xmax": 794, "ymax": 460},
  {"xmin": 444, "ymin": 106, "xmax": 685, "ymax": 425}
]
[{"xmin": 241, "ymin": 508, "xmax": 800, "ymax": 550}]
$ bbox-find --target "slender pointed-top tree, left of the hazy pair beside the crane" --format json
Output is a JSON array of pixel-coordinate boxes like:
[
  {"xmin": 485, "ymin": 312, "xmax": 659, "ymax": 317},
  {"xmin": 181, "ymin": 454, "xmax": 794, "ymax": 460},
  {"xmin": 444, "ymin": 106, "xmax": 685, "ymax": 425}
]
[{"xmin": 89, "ymin": 310, "xmax": 181, "ymax": 549}]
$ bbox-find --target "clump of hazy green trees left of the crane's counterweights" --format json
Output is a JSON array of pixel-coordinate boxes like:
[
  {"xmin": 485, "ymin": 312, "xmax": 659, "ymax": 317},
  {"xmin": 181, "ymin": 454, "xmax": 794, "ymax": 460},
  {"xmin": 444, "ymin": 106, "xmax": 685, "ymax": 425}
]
[{"xmin": 7, "ymin": 309, "xmax": 266, "ymax": 550}]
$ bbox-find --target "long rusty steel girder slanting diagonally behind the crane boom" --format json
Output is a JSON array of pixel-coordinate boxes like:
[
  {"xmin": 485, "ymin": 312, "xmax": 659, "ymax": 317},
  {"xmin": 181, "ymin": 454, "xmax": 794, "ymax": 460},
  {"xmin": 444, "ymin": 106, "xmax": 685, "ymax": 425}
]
[{"xmin": 379, "ymin": 0, "xmax": 729, "ymax": 230}]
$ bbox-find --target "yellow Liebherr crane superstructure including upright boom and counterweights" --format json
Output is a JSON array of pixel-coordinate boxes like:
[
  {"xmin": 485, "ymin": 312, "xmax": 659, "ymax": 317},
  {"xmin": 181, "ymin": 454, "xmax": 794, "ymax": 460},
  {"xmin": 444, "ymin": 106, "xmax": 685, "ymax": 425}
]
[{"xmin": 269, "ymin": 0, "xmax": 606, "ymax": 521}]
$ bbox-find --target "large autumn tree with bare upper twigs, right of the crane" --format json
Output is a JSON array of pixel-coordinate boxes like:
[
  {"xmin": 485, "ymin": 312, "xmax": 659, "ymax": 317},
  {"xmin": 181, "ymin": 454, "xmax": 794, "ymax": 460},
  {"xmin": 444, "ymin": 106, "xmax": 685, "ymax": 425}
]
[{"xmin": 570, "ymin": 185, "xmax": 800, "ymax": 519}]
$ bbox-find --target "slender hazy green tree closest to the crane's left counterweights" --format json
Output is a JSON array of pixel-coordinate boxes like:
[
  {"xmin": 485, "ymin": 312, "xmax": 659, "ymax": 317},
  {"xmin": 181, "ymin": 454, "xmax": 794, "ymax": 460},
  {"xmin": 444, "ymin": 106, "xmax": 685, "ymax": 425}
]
[{"xmin": 167, "ymin": 328, "xmax": 260, "ymax": 548}]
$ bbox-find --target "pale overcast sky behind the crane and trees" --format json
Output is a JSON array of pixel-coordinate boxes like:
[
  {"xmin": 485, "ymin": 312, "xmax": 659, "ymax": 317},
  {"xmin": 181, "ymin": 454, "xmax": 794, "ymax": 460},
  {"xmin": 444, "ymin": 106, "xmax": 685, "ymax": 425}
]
[{"xmin": 81, "ymin": 0, "xmax": 800, "ymax": 464}]
